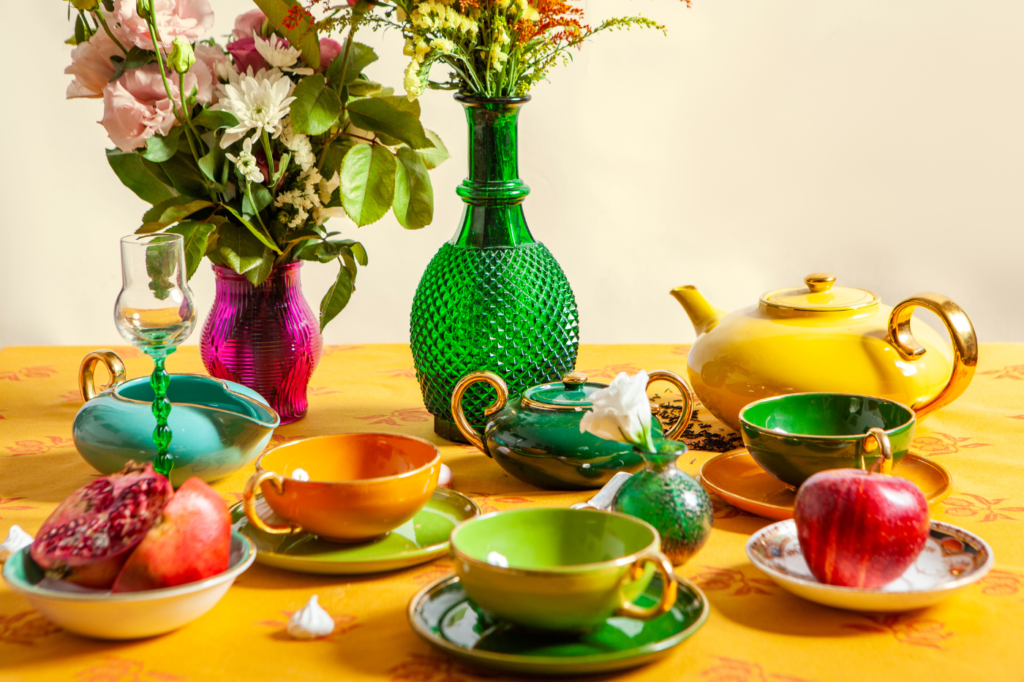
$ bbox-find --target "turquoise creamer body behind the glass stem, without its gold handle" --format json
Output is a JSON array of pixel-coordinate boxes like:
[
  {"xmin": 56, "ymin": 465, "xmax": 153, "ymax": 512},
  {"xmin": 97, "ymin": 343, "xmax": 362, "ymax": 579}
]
[{"xmin": 72, "ymin": 374, "xmax": 281, "ymax": 487}]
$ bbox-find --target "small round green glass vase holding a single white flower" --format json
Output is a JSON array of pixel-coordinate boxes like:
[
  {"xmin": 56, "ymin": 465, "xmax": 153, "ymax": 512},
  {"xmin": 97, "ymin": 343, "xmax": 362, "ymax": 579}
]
[{"xmin": 615, "ymin": 438, "xmax": 714, "ymax": 566}]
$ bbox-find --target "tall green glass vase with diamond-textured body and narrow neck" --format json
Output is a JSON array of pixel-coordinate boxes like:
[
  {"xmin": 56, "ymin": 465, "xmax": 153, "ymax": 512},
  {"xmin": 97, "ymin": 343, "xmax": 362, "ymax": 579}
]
[{"xmin": 411, "ymin": 95, "xmax": 580, "ymax": 441}]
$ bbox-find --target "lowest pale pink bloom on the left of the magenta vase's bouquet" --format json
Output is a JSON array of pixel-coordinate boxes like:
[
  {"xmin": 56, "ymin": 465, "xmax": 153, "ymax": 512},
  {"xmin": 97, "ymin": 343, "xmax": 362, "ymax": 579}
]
[{"xmin": 99, "ymin": 61, "xmax": 213, "ymax": 152}]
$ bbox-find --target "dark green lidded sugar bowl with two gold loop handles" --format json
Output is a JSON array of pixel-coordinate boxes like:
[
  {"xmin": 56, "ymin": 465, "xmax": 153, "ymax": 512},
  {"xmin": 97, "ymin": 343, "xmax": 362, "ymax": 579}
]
[{"xmin": 452, "ymin": 370, "xmax": 693, "ymax": 491}]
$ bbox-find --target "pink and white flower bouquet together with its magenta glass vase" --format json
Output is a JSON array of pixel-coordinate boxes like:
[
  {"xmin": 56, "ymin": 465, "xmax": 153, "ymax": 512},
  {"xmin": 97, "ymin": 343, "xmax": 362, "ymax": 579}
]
[{"xmin": 67, "ymin": 0, "xmax": 447, "ymax": 424}]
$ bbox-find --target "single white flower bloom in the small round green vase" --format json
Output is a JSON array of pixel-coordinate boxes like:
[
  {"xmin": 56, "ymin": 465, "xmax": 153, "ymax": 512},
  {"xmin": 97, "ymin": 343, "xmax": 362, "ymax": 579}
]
[{"xmin": 580, "ymin": 370, "xmax": 654, "ymax": 452}]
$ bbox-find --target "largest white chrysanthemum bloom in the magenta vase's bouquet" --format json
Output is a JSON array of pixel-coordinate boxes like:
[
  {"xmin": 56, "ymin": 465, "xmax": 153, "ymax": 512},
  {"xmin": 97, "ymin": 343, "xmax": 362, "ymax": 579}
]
[{"xmin": 211, "ymin": 70, "xmax": 295, "ymax": 148}]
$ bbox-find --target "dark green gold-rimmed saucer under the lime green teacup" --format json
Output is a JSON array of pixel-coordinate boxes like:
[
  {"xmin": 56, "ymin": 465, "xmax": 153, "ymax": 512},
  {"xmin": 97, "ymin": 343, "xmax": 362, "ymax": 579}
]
[{"xmin": 409, "ymin": 576, "xmax": 709, "ymax": 676}]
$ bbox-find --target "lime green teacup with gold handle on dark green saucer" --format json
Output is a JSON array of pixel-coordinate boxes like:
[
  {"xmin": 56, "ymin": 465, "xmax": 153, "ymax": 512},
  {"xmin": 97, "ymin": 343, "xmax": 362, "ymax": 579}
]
[{"xmin": 452, "ymin": 508, "xmax": 677, "ymax": 631}]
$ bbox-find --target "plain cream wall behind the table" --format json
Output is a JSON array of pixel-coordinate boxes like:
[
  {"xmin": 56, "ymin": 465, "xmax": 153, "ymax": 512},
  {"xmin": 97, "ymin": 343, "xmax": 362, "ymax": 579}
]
[{"xmin": 0, "ymin": 0, "xmax": 1024, "ymax": 346}]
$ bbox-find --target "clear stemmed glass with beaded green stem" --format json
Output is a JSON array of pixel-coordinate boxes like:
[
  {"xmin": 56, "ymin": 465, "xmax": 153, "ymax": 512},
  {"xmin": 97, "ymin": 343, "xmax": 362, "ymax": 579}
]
[{"xmin": 114, "ymin": 233, "xmax": 196, "ymax": 476}]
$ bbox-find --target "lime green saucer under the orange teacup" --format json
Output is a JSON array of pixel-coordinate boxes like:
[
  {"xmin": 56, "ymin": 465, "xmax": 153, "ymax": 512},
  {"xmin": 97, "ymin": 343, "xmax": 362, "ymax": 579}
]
[{"xmin": 231, "ymin": 487, "xmax": 480, "ymax": 576}]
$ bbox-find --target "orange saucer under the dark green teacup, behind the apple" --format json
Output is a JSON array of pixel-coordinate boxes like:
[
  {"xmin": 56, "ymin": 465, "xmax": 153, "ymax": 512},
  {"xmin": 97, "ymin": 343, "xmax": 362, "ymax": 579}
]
[{"xmin": 700, "ymin": 447, "xmax": 952, "ymax": 521}]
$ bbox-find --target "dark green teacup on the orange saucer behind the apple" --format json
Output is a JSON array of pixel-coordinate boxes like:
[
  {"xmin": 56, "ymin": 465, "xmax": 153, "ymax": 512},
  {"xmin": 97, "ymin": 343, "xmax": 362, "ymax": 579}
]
[{"xmin": 739, "ymin": 393, "xmax": 916, "ymax": 487}]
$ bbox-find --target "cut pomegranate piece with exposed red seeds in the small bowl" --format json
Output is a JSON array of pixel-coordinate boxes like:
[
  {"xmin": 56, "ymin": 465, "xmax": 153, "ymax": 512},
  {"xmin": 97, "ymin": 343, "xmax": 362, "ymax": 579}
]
[{"xmin": 31, "ymin": 462, "xmax": 174, "ymax": 589}]
